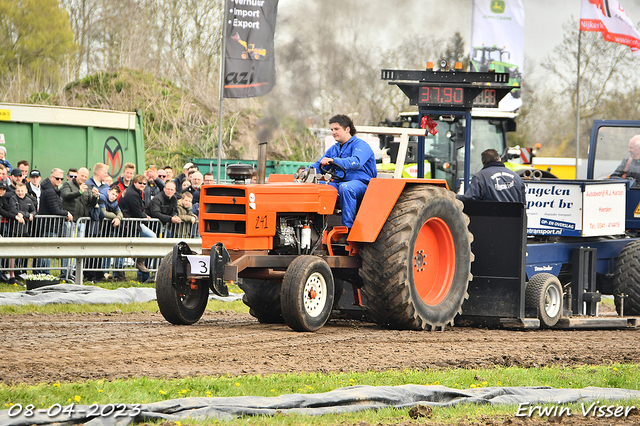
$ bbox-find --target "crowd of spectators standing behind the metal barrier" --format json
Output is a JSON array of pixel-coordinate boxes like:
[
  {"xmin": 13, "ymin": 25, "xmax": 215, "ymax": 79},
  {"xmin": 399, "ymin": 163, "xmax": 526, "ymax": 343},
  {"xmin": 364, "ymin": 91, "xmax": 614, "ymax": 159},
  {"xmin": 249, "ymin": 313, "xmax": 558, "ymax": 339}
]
[{"xmin": 0, "ymin": 151, "xmax": 204, "ymax": 284}]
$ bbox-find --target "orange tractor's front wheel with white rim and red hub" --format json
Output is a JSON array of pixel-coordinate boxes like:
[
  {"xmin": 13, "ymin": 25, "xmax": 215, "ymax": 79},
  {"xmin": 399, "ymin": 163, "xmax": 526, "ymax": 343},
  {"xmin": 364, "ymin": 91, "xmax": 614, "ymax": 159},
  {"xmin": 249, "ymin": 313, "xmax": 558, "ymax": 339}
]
[{"xmin": 280, "ymin": 256, "xmax": 334, "ymax": 331}]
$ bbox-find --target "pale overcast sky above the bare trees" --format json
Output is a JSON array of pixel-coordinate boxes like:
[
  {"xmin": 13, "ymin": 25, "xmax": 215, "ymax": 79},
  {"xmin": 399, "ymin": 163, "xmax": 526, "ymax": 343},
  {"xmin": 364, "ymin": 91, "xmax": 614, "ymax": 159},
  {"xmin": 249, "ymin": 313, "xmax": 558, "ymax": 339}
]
[{"xmin": 276, "ymin": 0, "xmax": 640, "ymax": 62}]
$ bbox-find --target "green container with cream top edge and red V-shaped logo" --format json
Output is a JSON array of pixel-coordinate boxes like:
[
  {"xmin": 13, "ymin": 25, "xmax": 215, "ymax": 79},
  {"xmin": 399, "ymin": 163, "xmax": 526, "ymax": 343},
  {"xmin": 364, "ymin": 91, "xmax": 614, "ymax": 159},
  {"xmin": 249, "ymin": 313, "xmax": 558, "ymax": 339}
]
[{"xmin": 0, "ymin": 103, "xmax": 145, "ymax": 179}]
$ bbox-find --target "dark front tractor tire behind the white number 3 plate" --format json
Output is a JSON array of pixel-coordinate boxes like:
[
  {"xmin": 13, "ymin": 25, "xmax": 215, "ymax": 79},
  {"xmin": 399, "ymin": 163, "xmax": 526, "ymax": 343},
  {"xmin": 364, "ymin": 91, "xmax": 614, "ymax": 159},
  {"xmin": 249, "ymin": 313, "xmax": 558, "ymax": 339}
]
[{"xmin": 156, "ymin": 253, "xmax": 209, "ymax": 325}]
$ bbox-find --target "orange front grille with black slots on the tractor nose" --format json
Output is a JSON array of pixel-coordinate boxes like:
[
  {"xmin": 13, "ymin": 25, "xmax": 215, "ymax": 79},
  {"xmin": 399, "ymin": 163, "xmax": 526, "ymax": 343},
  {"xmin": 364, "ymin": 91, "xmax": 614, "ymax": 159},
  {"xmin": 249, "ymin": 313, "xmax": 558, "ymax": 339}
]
[{"xmin": 200, "ymin": 187, "xmax": 247, "ymax": 234}]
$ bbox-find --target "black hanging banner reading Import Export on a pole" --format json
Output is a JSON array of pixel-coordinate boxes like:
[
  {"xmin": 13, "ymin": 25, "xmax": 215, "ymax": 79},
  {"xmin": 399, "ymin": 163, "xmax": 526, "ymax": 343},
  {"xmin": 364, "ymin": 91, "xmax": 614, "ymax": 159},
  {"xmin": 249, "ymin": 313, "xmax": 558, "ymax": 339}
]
[{"xmin": 224, "ymin": 0, "xmax": 278, "ymax": 98}]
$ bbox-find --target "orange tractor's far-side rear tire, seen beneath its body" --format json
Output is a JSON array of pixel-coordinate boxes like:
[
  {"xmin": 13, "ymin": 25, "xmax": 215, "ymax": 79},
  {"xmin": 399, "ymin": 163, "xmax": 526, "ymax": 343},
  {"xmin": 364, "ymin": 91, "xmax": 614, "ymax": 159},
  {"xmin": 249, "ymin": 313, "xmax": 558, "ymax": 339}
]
[{"xmin": 238, "ymin": 278, "xmax": 284, "ymax": 324}]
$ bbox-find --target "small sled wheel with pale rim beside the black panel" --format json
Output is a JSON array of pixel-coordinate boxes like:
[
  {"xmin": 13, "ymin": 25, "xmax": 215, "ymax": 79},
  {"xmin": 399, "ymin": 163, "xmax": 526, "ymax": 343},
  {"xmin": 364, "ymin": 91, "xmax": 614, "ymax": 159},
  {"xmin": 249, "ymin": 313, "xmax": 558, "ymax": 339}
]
[{"xmin": 525, "ymin": 273, "xmax": 562, "ymax": 328}]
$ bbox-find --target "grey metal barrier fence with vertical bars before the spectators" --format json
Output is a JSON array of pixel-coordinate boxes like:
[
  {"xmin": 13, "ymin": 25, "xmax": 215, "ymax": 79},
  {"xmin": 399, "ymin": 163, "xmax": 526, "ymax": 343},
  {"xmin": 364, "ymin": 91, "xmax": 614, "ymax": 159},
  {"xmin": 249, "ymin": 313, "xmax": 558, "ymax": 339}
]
[{"xmin": 0, "ymin": 215, "xmax": 199, "ymax": 281}]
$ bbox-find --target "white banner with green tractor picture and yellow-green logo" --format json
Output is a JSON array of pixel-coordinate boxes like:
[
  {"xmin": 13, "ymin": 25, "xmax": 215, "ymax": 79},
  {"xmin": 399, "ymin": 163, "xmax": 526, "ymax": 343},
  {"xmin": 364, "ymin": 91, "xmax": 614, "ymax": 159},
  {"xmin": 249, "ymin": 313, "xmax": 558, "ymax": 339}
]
[{"xmin": 469, "ymin": 0, "xmax": 524, "ymax": 111}]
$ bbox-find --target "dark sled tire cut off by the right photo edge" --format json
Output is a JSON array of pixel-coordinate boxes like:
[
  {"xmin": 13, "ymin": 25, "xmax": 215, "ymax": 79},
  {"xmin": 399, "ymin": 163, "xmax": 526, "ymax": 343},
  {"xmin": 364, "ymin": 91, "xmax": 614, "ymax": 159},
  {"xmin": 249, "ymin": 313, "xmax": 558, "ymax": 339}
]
[{"xmin": 613, "ymin": 241, "xmax": 640, "ymax": 315}]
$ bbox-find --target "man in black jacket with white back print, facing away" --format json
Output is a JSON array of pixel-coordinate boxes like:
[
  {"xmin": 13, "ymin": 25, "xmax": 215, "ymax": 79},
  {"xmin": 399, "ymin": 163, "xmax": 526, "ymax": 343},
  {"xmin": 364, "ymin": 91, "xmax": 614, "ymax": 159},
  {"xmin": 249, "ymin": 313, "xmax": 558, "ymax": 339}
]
[{"xmin": 457, "ymin": 149, "xmax": 526, "ymax": 205}]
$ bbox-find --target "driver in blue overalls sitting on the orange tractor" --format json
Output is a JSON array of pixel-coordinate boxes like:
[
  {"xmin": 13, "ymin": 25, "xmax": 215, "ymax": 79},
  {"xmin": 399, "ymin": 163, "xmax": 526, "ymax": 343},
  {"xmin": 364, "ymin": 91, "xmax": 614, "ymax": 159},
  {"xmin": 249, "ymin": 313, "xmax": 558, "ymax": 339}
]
[{"xmin": 312, "ymin": 114, "xmax": 377, "ymax": 229}]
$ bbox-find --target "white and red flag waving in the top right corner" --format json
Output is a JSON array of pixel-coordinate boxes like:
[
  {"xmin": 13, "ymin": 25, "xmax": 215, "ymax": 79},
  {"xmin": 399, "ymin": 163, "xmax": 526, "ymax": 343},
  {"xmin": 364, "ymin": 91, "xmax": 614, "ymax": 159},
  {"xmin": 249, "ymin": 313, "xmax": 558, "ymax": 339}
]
[{"xmin": 580, "ymin": 0, "xmax": 640, "ymax": 56}]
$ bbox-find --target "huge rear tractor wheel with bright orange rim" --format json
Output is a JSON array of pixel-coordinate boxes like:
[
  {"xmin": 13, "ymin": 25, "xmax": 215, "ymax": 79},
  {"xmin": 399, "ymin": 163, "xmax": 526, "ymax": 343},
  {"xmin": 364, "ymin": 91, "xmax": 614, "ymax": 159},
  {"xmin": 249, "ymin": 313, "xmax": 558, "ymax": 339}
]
[{"xmin": 360, "ymin": 185, "xmax": 473, "ymax": 330}]
